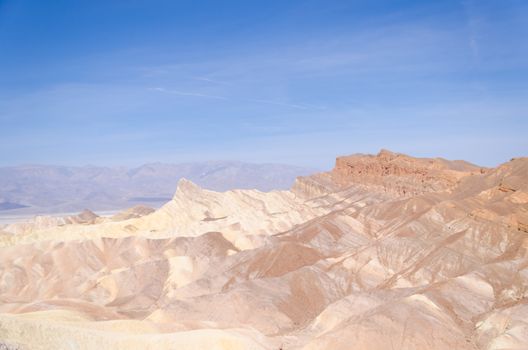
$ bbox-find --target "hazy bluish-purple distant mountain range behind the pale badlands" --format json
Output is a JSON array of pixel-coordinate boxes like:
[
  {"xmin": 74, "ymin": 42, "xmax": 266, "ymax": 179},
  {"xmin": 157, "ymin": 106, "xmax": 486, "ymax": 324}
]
[{"xmin": 0, "ymin": 162, "xmax": 315, "ymax": 214}]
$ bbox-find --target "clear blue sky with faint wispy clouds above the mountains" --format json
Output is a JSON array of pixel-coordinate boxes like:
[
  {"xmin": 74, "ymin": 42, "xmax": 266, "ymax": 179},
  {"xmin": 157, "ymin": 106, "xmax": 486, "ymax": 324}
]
[{"xmin": 0, "ymin": 0, "xmax": 528, "ymax": 168}]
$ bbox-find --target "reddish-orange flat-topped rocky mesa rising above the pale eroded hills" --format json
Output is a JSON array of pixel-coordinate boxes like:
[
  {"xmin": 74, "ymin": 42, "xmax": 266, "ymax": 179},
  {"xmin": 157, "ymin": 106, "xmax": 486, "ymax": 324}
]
[{"xmin": 330, "ymin": 150, "xmax": 485, "ymax": 196}]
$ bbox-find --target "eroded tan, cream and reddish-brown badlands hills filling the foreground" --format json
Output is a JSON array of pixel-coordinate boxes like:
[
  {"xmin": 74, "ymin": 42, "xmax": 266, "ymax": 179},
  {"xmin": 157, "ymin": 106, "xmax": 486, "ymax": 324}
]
[{"xmin": 0, "ymin": 150, "xmax": 528, "ymax": 350}]
